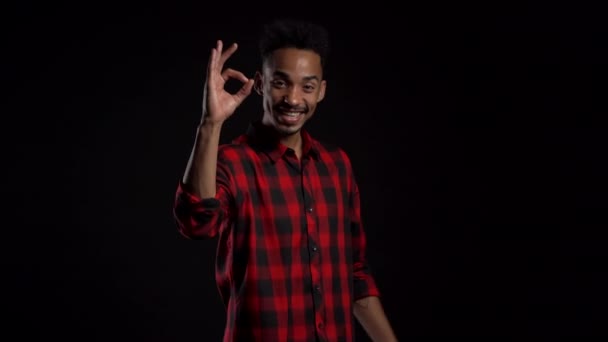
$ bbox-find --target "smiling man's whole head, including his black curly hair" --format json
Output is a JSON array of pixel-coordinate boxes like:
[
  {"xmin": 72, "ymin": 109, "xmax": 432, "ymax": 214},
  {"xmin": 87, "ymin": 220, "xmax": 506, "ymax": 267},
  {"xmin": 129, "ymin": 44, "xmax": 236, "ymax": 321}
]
[{"xmin": 255, "ymin": 20, "xmax": 329, "ymax": 136}]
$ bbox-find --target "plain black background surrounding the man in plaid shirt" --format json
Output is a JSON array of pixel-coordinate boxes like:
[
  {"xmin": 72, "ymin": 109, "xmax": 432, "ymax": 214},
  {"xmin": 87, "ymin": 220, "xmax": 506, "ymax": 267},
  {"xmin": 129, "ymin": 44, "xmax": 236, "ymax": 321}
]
[{"xmin": 2, "ymin": 1, "xmax": 608, "ymax": 341}]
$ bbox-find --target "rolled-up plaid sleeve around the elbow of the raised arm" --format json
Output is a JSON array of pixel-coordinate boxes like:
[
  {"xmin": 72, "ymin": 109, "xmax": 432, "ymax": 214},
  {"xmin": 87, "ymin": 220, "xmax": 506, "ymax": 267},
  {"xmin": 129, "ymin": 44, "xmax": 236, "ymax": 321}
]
[{"xmin": 173, "ymin": 151, "xmax": 238, "ymax": 240}]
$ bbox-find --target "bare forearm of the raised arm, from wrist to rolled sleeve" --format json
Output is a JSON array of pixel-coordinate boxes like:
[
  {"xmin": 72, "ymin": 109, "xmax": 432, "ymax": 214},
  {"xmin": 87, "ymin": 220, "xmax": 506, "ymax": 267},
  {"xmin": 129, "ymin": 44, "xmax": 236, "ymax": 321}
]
[{"xmin": 182, "ymin": 121, "xmax": 222, "ymax": 198}]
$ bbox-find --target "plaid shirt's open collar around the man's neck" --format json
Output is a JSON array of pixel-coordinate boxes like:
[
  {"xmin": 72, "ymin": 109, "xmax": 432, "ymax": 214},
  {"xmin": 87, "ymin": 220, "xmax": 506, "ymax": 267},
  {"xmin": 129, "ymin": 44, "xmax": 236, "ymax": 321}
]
[{"xmin": 240, "ymin": 121, "xmax": 319, "ymax": 162}]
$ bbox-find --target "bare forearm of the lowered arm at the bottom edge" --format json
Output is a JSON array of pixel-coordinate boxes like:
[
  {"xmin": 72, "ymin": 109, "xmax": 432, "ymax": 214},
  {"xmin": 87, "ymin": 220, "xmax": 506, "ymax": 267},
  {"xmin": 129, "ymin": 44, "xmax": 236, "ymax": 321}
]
[{"xmin": 354, "ymin": 296, "xmax": 397, "ymax": 342}]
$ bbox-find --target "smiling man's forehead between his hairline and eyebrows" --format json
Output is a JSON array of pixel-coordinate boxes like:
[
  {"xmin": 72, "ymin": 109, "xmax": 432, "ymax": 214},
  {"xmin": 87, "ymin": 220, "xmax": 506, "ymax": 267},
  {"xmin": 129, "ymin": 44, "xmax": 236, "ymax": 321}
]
[{"xmin": 264, "ymin": 48, "xmax": 322, "ymax": 79}]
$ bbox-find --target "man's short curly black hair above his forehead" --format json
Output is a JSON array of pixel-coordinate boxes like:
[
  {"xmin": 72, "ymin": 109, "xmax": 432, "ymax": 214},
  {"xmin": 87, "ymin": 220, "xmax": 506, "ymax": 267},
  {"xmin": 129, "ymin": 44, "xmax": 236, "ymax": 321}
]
[{"xmin": 259, "ymin": 18, "xmax": 329, "ymax": 68}]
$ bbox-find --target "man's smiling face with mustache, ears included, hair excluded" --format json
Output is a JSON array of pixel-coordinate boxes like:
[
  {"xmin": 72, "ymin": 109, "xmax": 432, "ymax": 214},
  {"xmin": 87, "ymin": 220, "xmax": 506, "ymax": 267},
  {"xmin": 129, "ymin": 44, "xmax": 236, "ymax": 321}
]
[{"xmin": 255, "ymin": 48, "xmax": 325, "ymax": 136}]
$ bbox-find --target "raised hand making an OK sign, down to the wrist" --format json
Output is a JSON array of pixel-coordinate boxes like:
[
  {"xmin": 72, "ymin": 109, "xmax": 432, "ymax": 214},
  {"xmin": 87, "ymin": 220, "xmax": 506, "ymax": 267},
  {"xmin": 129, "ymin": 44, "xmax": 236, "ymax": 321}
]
[{"xmin": 202, "ymin": 40, "xmax": 253, "ymax": 123}]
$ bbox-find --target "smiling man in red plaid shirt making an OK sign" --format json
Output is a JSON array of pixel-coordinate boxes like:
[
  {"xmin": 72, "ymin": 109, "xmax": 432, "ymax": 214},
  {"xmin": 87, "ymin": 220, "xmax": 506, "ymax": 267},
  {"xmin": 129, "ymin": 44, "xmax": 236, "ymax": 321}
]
[{"xmin": 174, "ymin": 20, "xmax": 396, "ymax": 342}]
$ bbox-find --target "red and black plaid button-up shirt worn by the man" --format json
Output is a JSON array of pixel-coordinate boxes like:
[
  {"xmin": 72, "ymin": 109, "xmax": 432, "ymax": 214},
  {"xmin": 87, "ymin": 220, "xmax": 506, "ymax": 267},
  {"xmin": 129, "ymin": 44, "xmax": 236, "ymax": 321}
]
[{"xmin": 174, "ymin": 121, "xmax": 379, "ymax": 342}]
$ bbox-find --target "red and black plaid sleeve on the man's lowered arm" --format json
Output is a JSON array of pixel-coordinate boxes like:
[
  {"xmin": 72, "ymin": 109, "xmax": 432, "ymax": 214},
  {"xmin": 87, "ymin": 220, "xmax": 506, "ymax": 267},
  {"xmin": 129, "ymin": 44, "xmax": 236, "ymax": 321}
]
[{"xmin": 347, "ymin": 152, "xmax": 380, "ymax": 300}]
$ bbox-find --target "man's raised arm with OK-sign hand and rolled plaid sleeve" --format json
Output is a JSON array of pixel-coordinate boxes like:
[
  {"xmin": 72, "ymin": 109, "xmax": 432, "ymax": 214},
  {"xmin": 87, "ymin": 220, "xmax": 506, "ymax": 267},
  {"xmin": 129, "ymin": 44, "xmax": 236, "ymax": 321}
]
[{"xmin": 173, "ymin": 41, "xmax": 253, "ymax": 239}]
